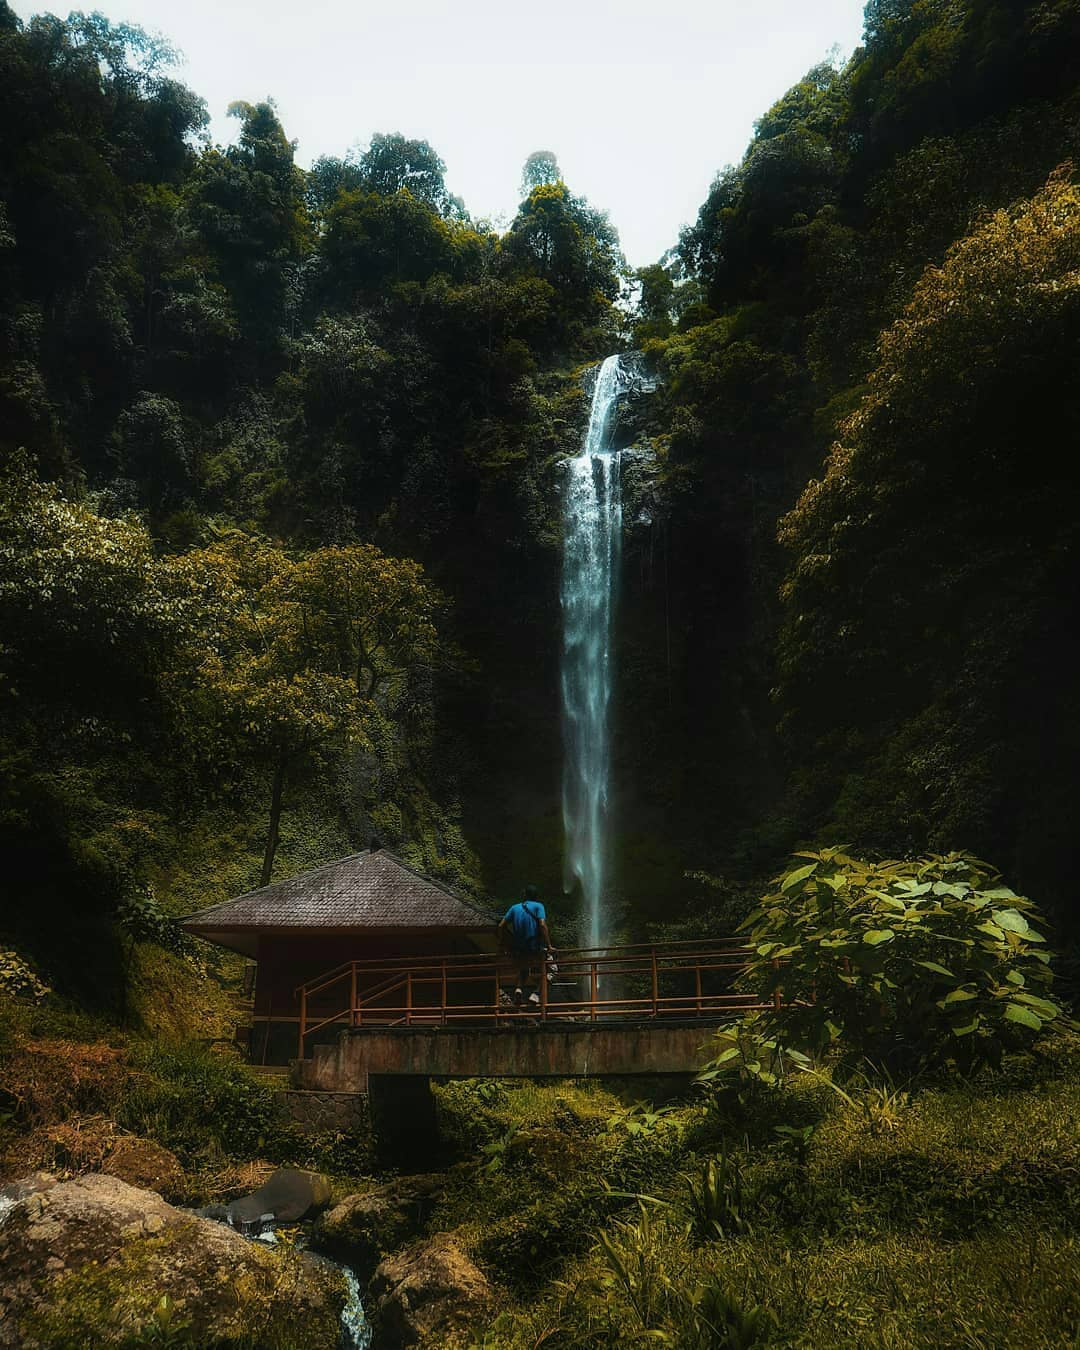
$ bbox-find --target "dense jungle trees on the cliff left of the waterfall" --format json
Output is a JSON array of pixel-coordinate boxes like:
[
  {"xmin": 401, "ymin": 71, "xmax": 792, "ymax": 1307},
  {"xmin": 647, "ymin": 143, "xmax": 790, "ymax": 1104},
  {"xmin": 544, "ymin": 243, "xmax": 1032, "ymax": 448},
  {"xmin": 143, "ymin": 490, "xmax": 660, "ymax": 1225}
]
[{"xmin": 0, "ymin": 5, "xmax": 625, "ymax": 994}]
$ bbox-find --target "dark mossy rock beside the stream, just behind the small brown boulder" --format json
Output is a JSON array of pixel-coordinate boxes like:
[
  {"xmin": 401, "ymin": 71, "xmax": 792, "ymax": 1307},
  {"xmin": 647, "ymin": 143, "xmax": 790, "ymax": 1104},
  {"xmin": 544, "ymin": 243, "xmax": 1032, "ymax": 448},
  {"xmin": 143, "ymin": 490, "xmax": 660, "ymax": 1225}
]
[{"xmin": 312, "ymin": 1173, "xmax": 446, "ymax": 1276}]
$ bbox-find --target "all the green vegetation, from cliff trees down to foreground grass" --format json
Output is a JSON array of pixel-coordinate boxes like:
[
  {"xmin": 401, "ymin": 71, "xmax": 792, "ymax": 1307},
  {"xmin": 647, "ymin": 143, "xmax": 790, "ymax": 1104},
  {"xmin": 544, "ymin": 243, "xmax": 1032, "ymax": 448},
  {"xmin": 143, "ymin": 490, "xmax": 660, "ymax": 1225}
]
[{"xmin": 0, "ymin": 0, "xmax": 1080, "ymax": 1350}]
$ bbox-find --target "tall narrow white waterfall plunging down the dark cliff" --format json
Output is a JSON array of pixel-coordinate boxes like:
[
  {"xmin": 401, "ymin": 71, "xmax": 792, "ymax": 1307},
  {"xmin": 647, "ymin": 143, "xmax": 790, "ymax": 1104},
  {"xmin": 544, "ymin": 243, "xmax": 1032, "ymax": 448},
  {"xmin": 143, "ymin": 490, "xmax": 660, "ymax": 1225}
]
[{"xmin": 562, "ymin": 356, "xmax": 629, "ymax": 946}]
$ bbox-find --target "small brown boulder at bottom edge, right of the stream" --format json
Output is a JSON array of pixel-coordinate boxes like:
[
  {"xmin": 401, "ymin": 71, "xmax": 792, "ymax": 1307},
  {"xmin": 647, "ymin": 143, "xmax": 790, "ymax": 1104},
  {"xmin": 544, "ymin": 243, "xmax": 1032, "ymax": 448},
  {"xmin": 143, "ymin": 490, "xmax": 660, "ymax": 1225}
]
[{"xmin": 369, "ymin": 1233, "xmax": 491, "ymax": 1347}]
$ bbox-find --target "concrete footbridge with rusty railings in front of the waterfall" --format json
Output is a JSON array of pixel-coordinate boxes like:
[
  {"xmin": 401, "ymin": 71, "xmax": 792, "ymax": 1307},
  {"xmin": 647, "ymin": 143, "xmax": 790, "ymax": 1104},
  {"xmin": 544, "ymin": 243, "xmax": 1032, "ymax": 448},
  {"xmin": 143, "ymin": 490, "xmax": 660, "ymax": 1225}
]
[{"xmin": 280, "ymin": 940, "xmax": 761, "ymax": 1149}]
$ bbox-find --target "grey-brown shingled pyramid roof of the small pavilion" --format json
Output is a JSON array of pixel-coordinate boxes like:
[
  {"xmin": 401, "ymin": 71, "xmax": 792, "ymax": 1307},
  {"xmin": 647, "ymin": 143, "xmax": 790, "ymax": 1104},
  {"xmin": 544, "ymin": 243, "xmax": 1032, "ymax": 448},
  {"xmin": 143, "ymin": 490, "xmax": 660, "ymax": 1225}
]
[{"xmin": 181, "ymin": 849, "xmax": 494, "ymax": 952}]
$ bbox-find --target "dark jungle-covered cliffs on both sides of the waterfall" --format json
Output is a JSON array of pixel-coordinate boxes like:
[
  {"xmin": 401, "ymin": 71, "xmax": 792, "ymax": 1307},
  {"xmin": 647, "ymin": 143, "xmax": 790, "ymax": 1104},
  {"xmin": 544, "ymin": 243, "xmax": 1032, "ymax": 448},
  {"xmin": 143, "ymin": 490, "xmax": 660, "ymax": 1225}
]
[{"xmin": 0, "ymin": 0, "xmax": 1080, "ymax": 986}]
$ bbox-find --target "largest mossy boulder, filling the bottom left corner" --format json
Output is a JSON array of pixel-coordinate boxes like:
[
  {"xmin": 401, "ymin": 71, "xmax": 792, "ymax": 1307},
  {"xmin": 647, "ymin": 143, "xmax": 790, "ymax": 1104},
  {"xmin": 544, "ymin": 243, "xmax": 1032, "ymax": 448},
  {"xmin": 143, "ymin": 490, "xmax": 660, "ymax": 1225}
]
[{"xmin": 0, "ymin": 1173, "xmax": 344, "ymax": 1350}]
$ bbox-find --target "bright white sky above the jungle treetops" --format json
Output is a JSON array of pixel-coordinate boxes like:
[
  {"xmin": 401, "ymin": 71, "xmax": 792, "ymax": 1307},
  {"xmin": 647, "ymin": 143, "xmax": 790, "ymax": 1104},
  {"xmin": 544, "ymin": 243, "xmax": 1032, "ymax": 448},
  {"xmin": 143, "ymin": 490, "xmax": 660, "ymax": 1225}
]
[{"xmin": 14, "ymin": 0, "xmax": 863, "ymax": 266}]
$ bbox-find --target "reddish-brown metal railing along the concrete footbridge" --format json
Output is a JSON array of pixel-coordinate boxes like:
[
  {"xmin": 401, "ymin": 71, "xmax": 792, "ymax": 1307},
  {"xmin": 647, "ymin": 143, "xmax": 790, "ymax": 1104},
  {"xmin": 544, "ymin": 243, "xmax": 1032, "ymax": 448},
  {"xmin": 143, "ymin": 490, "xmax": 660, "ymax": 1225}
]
[{"xmin": 296, "ymin": 938, "xmax": 780, "ymax": 1058}]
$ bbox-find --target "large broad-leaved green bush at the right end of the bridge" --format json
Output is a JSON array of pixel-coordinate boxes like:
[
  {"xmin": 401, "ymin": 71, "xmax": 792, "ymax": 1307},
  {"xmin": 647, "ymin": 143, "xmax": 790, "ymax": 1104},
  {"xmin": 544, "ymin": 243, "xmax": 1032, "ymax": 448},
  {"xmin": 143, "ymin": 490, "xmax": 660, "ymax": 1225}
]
[{"xmin": 713, "ymin": 848, "xmax": 1064, "ymax": 1068}]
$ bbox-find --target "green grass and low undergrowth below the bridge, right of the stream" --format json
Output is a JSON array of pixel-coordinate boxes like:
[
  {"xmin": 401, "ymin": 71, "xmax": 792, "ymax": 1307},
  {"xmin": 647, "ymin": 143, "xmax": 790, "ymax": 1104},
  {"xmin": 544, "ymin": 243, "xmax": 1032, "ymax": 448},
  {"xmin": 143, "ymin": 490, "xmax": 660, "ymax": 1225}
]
[{"xmin": 435, "ymin": 1031, "xmax": 1080, "ymax": 1350}]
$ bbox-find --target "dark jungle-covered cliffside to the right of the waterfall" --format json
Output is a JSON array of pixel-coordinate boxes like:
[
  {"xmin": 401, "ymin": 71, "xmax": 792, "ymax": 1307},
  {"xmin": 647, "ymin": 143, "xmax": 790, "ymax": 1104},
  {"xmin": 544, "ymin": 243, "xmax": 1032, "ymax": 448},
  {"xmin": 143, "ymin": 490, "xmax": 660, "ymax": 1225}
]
[{"xmin": 622, "ymin": 0, "xmax": 1080, "ymax": 966}]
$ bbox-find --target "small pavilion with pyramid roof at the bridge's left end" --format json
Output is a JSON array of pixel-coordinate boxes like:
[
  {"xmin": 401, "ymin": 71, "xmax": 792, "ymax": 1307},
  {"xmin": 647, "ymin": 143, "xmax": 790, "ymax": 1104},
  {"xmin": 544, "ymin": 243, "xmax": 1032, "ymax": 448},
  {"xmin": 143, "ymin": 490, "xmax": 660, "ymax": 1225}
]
[{"xmin": 181, "ymin": 842, "xmax": 495, "ymax": 1064}]
